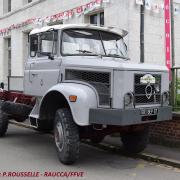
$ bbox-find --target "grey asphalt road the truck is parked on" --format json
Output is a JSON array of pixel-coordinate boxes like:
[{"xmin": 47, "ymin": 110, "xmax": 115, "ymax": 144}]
[{"xmin": 0, "ymin": 125, "xmax": 180, "ymax": 180}]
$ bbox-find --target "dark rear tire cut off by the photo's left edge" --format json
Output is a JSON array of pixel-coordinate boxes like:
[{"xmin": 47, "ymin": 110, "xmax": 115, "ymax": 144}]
[{"xmin": 0, "ymin": 109, "xmax": 8, "ymax": 137}]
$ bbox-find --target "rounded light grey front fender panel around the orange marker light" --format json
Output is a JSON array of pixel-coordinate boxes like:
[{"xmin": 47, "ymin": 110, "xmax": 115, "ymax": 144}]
[{"xmin": 39, "ymin": 82, "xmax": 98, "ymax": 126}]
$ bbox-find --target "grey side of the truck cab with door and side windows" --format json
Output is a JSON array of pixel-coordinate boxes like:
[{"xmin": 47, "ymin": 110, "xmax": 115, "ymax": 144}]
[{"xmin": 24, "ymin": 30, "xmax": 61, "ymax": 96}]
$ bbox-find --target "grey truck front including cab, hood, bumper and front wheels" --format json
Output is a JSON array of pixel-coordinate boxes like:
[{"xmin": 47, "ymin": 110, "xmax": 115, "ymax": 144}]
[{"xmin": 0, "ymin": 25, "xmax": 172, "ymax": 164}]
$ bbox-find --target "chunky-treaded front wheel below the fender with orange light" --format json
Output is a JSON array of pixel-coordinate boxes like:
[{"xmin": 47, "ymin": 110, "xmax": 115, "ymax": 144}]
[{"xmin": 54, "ymin": 108, "xmax": 80, "ymax": 165}]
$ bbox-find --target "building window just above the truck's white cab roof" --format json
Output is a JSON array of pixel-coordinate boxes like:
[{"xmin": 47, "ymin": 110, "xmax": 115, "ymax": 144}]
[{"xmin": 90, "ymin": 12, "xmax": 104, "ymax": 26}]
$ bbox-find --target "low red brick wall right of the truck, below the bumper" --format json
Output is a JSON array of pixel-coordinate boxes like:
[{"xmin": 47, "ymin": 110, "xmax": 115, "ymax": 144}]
[{"xmin": 150, "ymin": 117, "xmax": 180, "ymax": 147}]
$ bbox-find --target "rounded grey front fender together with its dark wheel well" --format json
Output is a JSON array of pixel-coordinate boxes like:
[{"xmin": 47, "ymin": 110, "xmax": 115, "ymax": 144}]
[{"xmin": 39, "ymin": 83, "xmax": 98, "ymax": 126}]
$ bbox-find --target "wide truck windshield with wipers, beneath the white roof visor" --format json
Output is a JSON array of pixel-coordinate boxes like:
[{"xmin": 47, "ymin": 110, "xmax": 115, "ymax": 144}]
[{"xmin": 62, "ymin": 29, "xmax": 127, "ymax": 58}]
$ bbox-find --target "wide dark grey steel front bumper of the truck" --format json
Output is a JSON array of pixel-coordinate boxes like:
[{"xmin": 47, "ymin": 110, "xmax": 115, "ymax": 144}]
[{"xmin": 89, "ymin": 106, "xmax": 172, "ymax": 126}]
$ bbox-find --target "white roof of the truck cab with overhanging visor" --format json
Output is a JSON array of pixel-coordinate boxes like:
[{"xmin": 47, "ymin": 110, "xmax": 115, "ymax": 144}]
[{"xmin": 30, "ymin": 24, "xmax": 128, "ymax": 37}]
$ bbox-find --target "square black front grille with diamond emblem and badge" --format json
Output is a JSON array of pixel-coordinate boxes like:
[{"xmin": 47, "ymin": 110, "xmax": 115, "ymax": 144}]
[{"xmin": 134, "ymin": 74, "xmax": 161, "ymax": 105}]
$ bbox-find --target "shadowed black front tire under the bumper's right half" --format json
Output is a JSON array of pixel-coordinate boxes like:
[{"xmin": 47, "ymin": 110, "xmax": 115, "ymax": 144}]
[{"xmin": 121, "ymin": 128, "xmax": 149, "ymax": 154}]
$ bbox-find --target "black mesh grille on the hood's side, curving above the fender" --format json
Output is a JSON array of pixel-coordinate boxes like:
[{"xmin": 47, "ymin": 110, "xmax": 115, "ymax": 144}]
[{"xmin": 65, "ymin": 69, "xmax": 111, "ymax": 106}]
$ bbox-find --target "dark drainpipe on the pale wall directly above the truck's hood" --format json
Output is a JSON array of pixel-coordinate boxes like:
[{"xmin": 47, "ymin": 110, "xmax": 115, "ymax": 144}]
[{"xmin": 140, "ymin": 1, "xmax": 145, "ymax": 63}]
